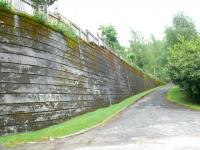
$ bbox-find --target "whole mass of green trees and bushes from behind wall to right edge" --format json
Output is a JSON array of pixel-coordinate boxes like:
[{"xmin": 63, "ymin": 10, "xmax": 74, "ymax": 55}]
[{"xmin": 100, "ymin": 13, "xmax": 200, "ymax": 94}]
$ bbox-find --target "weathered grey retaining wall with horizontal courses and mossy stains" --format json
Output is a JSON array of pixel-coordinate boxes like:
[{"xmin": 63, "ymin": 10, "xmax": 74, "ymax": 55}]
[{"xmin": 0, "ymin": 10, "xmax": 159, "ymax": 135}]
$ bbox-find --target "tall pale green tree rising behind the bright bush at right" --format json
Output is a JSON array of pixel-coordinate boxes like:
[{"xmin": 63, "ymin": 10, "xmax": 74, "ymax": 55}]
[{"xmin": 162, "ymin": 13, "xmax": 198, "ymax": 81}]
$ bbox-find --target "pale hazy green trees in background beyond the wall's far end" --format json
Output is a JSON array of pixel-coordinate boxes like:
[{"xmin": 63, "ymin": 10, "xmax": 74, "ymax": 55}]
[{"xmin": 128, "ymin": 31, "xmax": 168, "ymax": 80}]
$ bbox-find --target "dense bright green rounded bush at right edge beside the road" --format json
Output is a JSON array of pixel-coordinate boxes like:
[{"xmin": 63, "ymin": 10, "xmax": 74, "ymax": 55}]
[{"xmin": 169, "ymin": 37, "xmax": 200, "ymax": 102}]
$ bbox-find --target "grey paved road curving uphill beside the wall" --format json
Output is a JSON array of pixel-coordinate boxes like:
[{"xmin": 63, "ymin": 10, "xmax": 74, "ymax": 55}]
[{"xmin": 3, "ymin": 86, "xmax": 200, "ymax": 150}]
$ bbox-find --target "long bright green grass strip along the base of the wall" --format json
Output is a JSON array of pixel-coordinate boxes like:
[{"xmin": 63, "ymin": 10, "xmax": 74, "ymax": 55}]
[{"xmin": 0, "ymin": 88, "xmax": 157, "ymax": 147}]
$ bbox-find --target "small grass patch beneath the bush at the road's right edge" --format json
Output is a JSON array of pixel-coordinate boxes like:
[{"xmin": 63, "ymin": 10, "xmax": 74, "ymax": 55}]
[{"xmin": 167, "ymin": 86, "xmax": 200, "ymax": 111}]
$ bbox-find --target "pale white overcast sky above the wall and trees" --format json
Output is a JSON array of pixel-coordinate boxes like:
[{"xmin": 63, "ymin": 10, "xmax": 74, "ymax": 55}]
[{"xmin": 49, "ymin": 0, "xmax": 200, "ymax": 46}]
